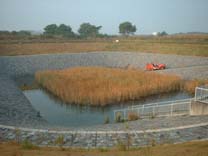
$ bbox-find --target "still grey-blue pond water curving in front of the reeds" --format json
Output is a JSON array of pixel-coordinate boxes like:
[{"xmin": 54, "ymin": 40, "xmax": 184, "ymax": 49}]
[{"xmin": 24, "ymin": 89, "xmax": 190, "ymax": 127}]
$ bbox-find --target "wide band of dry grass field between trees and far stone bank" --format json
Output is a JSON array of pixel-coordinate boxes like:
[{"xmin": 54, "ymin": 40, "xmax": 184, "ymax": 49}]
[{"xmin": 0, "ymin": 35, "xmax": 208, "ymax": 56}]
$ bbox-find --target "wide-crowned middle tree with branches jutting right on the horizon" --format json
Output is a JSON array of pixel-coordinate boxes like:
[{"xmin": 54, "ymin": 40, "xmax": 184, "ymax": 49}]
[{"xmin": 78, "ymin": 23, "xmax": 102, "ymax": 38}]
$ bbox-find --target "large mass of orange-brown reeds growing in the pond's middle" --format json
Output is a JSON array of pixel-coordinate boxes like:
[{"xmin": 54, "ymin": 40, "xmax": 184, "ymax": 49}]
[{"xmin": 35, "ymin": 67, "xmax": 181, "ymax": 105}]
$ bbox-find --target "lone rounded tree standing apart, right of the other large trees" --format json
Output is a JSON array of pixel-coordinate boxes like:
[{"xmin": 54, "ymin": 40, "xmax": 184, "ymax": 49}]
[{"xmin": 119, "ymin": 22, "xmax": 137, "ymax": 35}]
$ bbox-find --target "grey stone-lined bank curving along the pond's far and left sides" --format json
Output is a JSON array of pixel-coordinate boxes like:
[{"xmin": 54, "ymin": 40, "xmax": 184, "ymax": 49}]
[{"xmin": 0, "ymin": 52, "xmax": 208, "ymax": 127}]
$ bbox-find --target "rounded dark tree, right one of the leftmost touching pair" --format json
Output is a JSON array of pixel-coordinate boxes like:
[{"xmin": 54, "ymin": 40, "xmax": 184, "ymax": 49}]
[{"xmin": 56, "ymin": 24, "xmax": 75, "ymax": 38}]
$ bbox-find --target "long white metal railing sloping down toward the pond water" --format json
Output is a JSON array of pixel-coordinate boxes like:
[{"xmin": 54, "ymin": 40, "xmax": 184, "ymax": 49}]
[{"xmin": 114, "ymin": 98, "xmax": 193, "ymax": 120}]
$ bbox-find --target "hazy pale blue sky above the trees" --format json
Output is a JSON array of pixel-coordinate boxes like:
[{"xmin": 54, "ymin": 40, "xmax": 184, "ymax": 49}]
[{"xmin": 0, "ymin": 0, "xmax": 208, "ymax": 34}]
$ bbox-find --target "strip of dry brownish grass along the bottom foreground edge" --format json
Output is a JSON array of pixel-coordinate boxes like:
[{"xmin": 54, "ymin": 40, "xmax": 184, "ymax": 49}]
[{"xmin": 0, "ymin": 141, "xmax": 208, "ymax": 156}]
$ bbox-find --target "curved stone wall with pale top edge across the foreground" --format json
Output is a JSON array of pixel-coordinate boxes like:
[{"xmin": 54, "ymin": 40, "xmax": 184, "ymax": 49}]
[{"xmin": 0, "ymin": 123, "xmax": 208, "ymax": 148}]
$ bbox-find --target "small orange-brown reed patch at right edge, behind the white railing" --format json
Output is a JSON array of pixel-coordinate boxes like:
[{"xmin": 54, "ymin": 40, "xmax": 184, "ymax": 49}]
[{"xmin": 184, "ymin": 79, "xmax": 208, "ymax": 94}]
